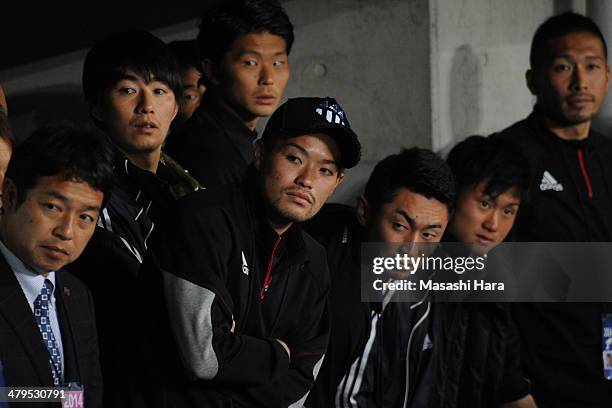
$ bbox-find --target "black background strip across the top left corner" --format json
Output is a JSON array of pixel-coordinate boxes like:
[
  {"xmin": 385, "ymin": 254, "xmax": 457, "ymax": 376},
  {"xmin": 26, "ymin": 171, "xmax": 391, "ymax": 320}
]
[{"xmin": 0, "ymin": 0, "xmax": 207, "ymax": 70}]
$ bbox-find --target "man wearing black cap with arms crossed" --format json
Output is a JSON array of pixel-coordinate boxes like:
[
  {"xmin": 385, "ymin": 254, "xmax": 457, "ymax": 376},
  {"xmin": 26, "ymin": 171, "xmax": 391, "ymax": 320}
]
[{"xmin": 145, "ymin": 98, "xmax": 361, "ymax": 407}]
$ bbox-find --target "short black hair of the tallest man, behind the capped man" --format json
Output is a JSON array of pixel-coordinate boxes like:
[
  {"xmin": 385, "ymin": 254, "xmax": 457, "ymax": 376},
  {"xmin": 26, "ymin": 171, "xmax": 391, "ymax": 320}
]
[{"xmin": 197, "ymin": 0, "xmax": 294, "ymax": 63}]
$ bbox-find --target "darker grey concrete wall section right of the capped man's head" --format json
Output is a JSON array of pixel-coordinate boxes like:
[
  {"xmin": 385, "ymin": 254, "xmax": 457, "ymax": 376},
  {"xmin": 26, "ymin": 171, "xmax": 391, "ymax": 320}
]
[{"xmin": 284, "ymin": 0, "xmax": 431, "ymax": 203}]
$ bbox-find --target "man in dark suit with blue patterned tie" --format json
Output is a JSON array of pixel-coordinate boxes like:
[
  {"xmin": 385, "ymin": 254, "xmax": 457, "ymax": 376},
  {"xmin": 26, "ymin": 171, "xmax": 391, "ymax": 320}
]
[{"xmin": 0, "ymin": 126, "xmax": 113, "ymax": 408}]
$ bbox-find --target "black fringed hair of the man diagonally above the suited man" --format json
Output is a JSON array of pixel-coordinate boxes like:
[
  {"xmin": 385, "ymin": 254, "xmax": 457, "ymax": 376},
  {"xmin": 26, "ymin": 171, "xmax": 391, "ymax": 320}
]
[{"xmin": 83, "ymin": 30, "xmax": 183, "ymax": 105}]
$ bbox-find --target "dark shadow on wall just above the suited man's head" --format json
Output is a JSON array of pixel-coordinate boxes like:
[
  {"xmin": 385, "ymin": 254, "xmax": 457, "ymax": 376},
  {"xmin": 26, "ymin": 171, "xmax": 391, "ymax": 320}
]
[{"xmin": 8, "ymin": 84, "xmax": 91, "ymax": 142}]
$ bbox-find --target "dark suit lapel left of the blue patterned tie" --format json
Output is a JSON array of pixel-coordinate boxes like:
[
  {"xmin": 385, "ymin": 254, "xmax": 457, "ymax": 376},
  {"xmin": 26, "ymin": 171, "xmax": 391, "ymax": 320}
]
[{"xmin": 0, "ymin": 254, "xmax": 53, "ymax": 387}]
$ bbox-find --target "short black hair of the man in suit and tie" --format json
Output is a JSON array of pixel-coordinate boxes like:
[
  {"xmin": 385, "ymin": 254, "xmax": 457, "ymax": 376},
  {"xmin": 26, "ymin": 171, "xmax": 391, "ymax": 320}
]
[{"xmin": 6, "ymin": 122, "xmax": 114, "ymax": 203}]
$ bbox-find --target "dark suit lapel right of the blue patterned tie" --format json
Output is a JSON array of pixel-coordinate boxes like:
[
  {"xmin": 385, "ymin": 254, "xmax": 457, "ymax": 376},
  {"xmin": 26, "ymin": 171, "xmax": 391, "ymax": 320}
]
[{"xmin": 55, "ymin": 271, "xmax": 81, "ymax": 382}]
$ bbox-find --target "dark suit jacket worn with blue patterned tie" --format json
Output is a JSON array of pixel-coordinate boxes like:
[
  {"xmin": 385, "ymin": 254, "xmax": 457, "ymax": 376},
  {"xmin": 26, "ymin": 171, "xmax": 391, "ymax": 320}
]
[{"xmin": 0, "ymin": 255, "xmax": 102, "ymax": 408}]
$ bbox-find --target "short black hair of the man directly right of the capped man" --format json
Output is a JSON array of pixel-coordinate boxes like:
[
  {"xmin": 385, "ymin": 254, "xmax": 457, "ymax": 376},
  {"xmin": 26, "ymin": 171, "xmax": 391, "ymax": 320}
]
[{"xmin": 364, "ymin": 147, "xmax": 456, "ymax": 214}]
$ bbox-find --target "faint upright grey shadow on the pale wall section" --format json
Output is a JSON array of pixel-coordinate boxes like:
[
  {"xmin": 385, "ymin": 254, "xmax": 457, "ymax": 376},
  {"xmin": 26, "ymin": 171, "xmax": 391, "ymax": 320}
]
[{"xmin": 440, "ymin": 45, "xmax": 482, "ymax": 156}]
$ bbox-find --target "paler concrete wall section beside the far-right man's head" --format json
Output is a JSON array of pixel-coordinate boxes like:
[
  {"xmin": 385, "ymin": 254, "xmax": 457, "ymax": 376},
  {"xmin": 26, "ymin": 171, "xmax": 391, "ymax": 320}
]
[{"xmin": 432, "ymin": 0, "xmax": 554, "ymax": 151}]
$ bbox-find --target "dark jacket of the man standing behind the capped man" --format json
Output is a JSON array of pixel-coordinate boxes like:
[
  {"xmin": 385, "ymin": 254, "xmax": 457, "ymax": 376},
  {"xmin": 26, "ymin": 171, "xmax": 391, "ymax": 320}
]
[{"xmin": 164, "ymin": 91, "xmax": 257, "ymax": 188}]
